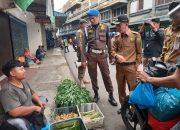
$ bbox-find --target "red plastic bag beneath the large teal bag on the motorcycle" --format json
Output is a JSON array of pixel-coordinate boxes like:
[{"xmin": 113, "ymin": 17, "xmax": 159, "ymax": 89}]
[{"xmin": 148, "ymin": 113, "xmax": 180, "ymax": 130}]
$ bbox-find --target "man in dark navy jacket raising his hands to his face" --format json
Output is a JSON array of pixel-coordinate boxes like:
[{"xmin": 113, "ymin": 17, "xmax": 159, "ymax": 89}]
[{"xmin": 139, "ymin": 18, "xmax": 164, "ymax": 65}]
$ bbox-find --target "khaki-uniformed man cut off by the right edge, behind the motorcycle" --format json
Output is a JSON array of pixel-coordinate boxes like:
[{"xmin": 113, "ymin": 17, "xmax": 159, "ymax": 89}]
[{"xmin": 161, "ymin": 2, "xmax": 180, "ymax": 64}]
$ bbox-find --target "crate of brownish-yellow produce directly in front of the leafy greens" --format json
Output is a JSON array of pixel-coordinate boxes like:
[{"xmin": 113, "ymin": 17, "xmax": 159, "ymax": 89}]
[{"xmin": 52, "ymin": 106, "xmax": 79, "ymax": 122}]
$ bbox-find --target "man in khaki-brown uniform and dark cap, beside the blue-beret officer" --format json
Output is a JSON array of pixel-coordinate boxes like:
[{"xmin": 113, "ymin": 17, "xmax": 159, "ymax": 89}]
[{"xmin": 112, "ymin": 15, "xmax": 142, "ymax": 113}]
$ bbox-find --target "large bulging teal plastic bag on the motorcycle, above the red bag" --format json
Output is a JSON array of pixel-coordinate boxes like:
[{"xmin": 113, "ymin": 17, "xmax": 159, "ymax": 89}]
[{"xmin": 149, "ymin": 87, "xmax": 180, "ymax": 121}]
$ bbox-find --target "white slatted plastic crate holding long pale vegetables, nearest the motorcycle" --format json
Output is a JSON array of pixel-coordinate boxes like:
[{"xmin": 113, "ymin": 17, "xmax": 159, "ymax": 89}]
[{"xmin": 78, "ymin": 103, "xmax": 104, "ymax": 129}]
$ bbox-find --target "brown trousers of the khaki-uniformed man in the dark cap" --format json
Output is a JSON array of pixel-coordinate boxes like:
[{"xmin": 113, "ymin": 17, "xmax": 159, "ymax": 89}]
[{"xmin": 116, "ymin": 63, "xmax": 137, "ymax": 104}]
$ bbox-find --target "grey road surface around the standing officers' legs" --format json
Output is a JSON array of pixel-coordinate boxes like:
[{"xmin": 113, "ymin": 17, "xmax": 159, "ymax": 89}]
[{"xmin": 65, "ymin": 46, "xmax": 126, "ymax": 130}]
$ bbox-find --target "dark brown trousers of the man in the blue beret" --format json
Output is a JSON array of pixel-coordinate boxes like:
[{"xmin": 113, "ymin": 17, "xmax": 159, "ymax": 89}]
[{"xmin": 87, "ymin": 52, "xmax": 113, "ymax": 93}]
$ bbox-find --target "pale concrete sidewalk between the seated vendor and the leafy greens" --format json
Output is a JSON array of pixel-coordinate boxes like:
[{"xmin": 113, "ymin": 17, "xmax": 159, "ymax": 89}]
[{"xmin": 26, "ymin": 48, "xmax": 73, "ymax": 119}]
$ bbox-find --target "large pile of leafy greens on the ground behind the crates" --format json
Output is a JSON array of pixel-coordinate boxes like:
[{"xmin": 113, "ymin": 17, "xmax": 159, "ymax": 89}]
[{"xmin": 55, "ymin": 79, "xmax": 92, "ymax": 107}]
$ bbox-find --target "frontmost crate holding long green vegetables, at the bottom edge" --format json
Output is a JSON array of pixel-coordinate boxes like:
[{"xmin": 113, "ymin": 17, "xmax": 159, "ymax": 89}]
[{"xmin": 49, "ymin": 118, "xmax": 87, "ymax": 130}]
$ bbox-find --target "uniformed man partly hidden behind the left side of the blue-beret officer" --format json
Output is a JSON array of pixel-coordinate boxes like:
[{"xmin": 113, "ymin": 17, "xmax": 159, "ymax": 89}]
[{"xmin": 76, "ymin": 19, "xmax": 90, "ymax": 87}]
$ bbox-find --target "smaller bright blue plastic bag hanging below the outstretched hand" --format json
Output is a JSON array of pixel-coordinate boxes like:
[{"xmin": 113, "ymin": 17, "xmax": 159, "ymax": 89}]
[{"xmin": 129, "ymin": 82, "xmax": 155, "ymax": 109}]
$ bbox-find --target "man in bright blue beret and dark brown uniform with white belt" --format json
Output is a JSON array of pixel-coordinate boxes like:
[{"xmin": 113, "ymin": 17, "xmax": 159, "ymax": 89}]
[{"xmin": 87, "ymin": 9, "xmax": 117, "ymax": 106}]
